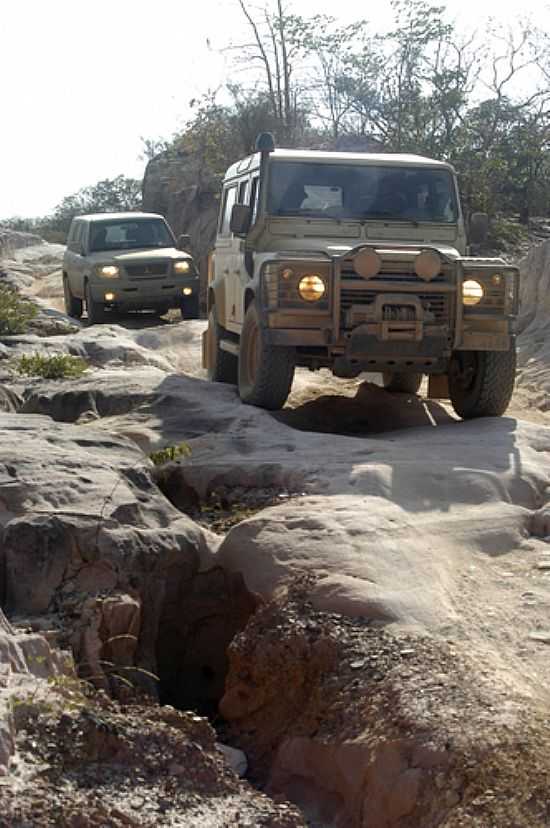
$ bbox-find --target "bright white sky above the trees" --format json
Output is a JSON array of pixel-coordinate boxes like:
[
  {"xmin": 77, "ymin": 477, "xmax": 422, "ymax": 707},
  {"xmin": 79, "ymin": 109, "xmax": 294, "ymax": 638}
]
[{"xmin": 0, "ymin": 0, "xmax": 550, "ymax": 219}]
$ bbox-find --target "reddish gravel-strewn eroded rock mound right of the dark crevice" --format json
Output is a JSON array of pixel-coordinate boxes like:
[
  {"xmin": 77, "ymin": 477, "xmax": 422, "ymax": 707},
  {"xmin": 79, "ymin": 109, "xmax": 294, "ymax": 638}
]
[{"xmin": 220, "ymin": 587, "xmax": 550, "ymax": 828}]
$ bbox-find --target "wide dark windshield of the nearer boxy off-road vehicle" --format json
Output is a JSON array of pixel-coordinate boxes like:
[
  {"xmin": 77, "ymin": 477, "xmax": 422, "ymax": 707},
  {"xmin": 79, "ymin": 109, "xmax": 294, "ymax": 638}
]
[{"xmin": 267, "ymin": 161, "xmax": 458, "ymax": 223}]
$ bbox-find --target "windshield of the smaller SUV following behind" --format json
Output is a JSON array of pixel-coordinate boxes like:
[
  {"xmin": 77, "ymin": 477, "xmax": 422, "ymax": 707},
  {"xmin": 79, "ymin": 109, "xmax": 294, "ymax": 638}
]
[{"xmin": 90, "ymin": 219, "xmax": 174, "ymax": 253}]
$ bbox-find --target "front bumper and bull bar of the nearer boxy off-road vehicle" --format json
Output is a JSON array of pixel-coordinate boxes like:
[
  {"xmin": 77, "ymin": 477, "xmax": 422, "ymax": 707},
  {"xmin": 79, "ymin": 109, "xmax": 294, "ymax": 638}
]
[{"xmin": 264, "ymin": 246, "xmax": 519, "ymax": 360}]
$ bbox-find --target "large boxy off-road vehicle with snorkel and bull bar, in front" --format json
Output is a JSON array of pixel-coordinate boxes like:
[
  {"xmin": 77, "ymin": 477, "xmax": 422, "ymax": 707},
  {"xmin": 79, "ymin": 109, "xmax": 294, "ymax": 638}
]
[{"xmin": 203, "ymin": 133, "xmax": 519, "ymax": 417}]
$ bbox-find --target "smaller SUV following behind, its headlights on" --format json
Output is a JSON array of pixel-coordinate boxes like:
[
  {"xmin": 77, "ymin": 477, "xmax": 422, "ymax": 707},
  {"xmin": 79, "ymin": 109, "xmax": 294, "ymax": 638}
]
[{"xmin": 63, "ymin": 213, "xmax": 199, "ymax": 325}]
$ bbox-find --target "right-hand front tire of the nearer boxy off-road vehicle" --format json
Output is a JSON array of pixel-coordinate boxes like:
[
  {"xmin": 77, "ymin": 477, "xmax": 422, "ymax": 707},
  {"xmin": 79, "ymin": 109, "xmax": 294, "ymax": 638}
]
[{"xmin": 449, "ymin": 347, "xmax": 516, "ymax": 420}]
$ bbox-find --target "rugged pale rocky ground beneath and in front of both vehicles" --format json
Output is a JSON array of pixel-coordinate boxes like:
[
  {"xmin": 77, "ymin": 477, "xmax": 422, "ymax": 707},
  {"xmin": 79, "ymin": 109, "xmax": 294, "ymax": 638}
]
[{"xmin": 0, "ymin": 236, "xmax": 550, "ymax": 828}]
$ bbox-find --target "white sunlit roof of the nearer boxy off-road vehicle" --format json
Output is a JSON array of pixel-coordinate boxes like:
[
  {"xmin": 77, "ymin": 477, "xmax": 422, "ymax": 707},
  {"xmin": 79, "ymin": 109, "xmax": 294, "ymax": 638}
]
[{"xmin": 225, "ymin": 149, "xmax": 453, "ymax": 180}]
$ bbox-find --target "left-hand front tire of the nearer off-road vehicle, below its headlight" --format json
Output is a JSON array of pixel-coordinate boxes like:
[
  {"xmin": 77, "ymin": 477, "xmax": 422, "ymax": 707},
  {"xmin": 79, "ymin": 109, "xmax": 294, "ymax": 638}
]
[{"xmin": 239, "ymin": 301, "xmax": 295, "ymax": 411}]
